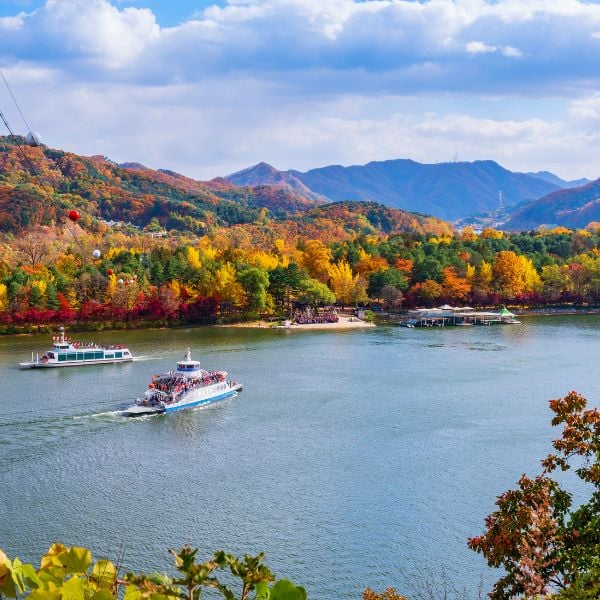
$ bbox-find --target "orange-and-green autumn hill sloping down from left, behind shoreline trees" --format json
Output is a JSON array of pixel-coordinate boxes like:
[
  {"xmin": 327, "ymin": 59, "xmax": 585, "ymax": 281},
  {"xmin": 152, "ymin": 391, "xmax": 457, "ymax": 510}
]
[{"xmin": 0, "ymin": 137, "xmax": 450, "ymax": 239}]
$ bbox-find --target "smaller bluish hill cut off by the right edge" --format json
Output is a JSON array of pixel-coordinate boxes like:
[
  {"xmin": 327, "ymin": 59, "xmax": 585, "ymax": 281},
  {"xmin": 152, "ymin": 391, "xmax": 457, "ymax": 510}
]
[{"xmin": 505, "ymin": 179, "xmax": 600, "ymax": 231}]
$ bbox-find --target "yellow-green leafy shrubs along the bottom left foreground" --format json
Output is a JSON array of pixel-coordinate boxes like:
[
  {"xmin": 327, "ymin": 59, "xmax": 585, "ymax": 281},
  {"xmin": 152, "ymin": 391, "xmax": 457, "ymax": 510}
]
[{"xmin": 0, "ymin": 544, "xmax": 306, "ymax": 600}]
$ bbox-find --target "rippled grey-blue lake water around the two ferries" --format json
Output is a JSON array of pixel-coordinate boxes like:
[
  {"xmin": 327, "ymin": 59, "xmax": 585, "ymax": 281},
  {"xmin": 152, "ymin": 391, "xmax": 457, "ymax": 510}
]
[{"xmin": 0, "ymin": 316, "xmax": 600, "ymax": 600}]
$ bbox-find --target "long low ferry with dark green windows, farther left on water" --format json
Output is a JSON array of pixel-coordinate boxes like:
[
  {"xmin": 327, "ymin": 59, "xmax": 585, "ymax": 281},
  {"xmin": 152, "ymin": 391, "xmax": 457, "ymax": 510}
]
[{"xmin": 19, "ymin": 327, "xmax": 133, "ymax": 369}]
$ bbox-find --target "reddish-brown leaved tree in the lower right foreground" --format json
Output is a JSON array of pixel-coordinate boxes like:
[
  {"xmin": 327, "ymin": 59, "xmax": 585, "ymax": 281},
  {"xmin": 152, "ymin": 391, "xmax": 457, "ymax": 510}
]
[{"xmin": 469, "ymin": 392, "xmax": 600, "ymax": 600}]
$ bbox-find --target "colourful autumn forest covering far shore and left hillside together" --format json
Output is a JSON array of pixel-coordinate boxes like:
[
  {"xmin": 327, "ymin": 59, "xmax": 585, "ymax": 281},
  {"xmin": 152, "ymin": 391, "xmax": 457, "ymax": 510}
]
[{"xmin": 0, "ymin": 138, "xmax": 600, "ymax": 332}]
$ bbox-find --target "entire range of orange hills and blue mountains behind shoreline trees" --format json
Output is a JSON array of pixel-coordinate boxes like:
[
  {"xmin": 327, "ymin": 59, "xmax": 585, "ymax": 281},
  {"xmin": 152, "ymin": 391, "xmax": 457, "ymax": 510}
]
[{"xmin": 0, "ymin": 137, "xmax": 600, "ymax": 237}]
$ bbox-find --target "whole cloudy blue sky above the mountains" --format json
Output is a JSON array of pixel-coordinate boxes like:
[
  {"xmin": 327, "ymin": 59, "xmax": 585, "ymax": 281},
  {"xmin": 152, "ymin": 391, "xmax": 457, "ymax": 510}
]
[{"xmin": 0, "ymin": 0, "xmax": 600, "ymax": 179}]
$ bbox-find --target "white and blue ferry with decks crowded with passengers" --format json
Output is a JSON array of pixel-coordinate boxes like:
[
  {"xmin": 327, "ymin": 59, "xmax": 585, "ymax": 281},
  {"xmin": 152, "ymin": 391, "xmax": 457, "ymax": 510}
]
[{"xmin": 124, "ymin": 348, "xmax": 242, "ymax": 417}]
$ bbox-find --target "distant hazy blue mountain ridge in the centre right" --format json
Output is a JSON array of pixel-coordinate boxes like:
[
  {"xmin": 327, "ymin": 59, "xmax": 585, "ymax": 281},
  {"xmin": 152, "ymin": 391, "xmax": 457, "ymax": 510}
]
[{"xmin": 227, "ymin": 160, "xmax": 559, "ymax": 220}]
